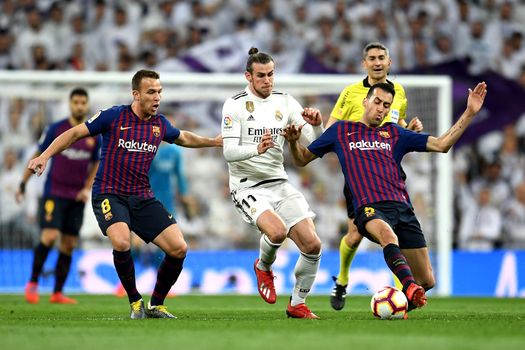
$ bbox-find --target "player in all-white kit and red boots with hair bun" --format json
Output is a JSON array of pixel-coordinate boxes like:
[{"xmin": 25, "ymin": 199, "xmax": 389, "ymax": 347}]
[{"xmin": 221, "ymin": 48, "xmax": 323, "ymax": 319}]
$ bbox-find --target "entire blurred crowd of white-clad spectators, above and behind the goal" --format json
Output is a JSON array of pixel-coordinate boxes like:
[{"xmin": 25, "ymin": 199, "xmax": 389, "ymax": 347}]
[{"xmin": 0, "ymin": 0, "xmax": 525, "ymax": 250}]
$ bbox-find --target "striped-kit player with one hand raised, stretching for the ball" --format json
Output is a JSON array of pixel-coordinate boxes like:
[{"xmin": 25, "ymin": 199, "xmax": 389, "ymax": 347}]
[{"xmin": 283, "ymin": 82, "xmax": 487, "ymax": 310}]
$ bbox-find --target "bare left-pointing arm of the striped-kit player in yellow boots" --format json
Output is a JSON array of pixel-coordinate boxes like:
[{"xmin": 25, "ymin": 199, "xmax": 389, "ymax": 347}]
[{"xmin": 27, "ymin": 124, "xmax": 89, "ymax": 176}]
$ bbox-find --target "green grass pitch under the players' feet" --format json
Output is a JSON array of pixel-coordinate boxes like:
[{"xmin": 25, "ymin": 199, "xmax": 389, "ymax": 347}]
[{"xmin": 0, "ymin": 295, "xmax": 525, "ymax": 350}]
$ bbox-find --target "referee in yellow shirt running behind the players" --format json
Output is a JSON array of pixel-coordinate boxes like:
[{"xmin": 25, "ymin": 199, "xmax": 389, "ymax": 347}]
[{"xmin": 326, "ymin": 42, "xmax": 423, "ymax": 310}]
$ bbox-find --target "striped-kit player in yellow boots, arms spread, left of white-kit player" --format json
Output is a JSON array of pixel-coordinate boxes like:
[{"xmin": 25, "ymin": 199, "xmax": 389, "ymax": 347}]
[{"xmin": 28, "ymin": 70, "xmax": 222, "ymax": 319}]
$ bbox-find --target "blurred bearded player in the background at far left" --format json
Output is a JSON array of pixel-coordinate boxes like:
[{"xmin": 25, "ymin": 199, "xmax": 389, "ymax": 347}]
[{"xmin": 16, "ymin": 88, "xmax": 100, "ymax": 304}]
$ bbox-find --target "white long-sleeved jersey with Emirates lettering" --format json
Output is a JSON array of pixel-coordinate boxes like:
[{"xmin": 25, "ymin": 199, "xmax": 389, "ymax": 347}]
[{"xmin": 221, "ymin": 87, "xmax": 322, "ymax": 191}]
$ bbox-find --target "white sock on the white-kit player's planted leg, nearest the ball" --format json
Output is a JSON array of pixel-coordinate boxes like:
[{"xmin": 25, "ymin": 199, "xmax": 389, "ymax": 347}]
[{"xmin": 291, "ymin": 252, "xmax": 321, "ymax": 306}]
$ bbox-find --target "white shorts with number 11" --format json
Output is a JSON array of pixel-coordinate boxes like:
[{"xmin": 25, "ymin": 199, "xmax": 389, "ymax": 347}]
[{"xmin": 231, "ymin": 181, "xmax": 315, "ymax": 231}]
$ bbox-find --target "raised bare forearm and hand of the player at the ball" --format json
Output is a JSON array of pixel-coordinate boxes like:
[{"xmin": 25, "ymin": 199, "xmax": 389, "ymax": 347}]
[{"xmin": 427, "ymin": 82, "xmax": 487, "ymax": 153}]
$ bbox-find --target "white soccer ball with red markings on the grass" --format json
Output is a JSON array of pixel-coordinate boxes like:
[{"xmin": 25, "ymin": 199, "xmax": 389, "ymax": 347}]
[{"xmin": 370, "ymin": 287, "xmax": 408, "ymax": 320}]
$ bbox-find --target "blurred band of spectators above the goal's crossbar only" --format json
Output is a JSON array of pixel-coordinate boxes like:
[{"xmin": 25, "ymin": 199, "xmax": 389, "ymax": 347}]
[{"xmin": 0, "ymin": 0, "xmax": 525, "ymax": 76}]
